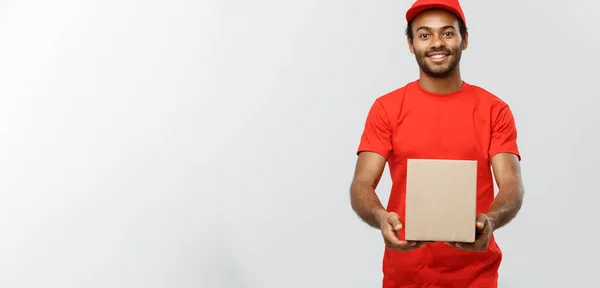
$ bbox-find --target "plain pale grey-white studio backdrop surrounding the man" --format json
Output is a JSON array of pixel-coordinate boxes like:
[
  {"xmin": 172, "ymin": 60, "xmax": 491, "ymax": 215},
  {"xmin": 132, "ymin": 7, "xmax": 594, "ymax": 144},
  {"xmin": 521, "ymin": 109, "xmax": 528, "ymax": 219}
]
[{"xmin": 0, "ymin": 0, "xmax": 600, "ymax": 288}]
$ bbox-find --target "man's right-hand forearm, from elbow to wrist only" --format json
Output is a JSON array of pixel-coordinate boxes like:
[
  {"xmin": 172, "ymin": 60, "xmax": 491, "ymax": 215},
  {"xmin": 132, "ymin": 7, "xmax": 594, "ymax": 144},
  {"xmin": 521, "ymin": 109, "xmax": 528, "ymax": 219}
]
[{"xmin": 487, "ymin": 181, "xmax": 524, "ymax": 230}]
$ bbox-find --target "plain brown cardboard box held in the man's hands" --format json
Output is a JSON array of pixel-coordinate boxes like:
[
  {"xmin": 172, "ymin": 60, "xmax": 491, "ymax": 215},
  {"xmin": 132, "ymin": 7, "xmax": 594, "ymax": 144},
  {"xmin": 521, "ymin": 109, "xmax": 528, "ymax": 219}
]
[{"xmin": 404, "ymin": 159, "xmax": 477, "ymax": 243}]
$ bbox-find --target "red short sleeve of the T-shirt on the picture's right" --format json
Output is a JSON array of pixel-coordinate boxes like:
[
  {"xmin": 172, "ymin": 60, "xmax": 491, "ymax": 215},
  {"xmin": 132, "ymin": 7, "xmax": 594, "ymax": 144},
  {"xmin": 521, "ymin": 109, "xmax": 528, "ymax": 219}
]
[{"xmin": 489, "ymin": 105, "xmax": 521, "ymax": 161}]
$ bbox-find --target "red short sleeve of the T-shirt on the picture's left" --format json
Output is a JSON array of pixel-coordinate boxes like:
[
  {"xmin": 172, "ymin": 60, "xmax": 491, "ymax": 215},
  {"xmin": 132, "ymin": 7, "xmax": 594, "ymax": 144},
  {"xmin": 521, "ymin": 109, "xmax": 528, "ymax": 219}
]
[{"xmin": 357, "ymin": 100, "xmax": 392, "ymax": 159}]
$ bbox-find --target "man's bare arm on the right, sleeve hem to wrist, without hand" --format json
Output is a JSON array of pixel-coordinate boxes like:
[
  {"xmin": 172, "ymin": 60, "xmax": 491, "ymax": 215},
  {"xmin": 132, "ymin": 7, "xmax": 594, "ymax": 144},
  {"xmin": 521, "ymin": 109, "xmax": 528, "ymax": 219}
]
[{"xmin": 487, "ymin": 153, "xmax": 524, "ymax": 230}]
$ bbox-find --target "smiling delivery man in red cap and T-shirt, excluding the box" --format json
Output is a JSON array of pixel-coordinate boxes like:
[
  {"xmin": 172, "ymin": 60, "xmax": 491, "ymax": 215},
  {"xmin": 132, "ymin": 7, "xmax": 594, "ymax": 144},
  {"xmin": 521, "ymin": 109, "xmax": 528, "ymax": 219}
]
[{"xmin": 350, "ymin": 0, "xmax": 523, "ymax": 288}]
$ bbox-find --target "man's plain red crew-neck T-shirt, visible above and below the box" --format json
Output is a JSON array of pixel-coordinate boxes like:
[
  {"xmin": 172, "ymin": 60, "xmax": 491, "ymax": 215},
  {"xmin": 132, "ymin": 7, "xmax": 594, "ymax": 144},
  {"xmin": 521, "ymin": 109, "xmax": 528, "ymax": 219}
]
[{"xmin": 358, "ymin": 80, "xmax": 521, "ymax": 288}]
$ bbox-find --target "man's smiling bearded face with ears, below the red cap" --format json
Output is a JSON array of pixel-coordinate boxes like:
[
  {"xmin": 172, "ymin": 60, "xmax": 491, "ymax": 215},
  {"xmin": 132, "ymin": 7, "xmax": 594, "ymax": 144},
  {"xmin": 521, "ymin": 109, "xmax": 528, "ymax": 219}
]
[{"xmin": 409, "ymin": 10, "xmax": 467, "ymax": 78}]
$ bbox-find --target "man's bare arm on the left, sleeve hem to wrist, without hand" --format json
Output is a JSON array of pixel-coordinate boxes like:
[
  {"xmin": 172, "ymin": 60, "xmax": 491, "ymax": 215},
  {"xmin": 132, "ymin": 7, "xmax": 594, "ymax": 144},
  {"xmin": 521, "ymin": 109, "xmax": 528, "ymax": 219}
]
[{"xmin": 350, "ymin": 151, "xmax": 386, "ymax": 229}]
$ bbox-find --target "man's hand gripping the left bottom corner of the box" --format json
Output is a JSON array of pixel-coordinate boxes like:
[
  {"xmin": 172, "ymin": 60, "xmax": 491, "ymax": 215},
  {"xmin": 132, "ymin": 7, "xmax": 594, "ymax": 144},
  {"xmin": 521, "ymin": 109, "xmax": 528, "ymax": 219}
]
[{"xmin": 378, "ymin": 211, "xmax": 430, "ymax": 252}]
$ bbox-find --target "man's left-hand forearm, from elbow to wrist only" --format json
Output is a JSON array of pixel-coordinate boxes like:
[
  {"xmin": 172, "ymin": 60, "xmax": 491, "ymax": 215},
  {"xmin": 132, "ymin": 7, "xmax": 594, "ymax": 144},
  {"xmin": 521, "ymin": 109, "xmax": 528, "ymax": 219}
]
[{"xmin": 350, "ymin": 182, "xmax": 386, "ymax": 229}]
